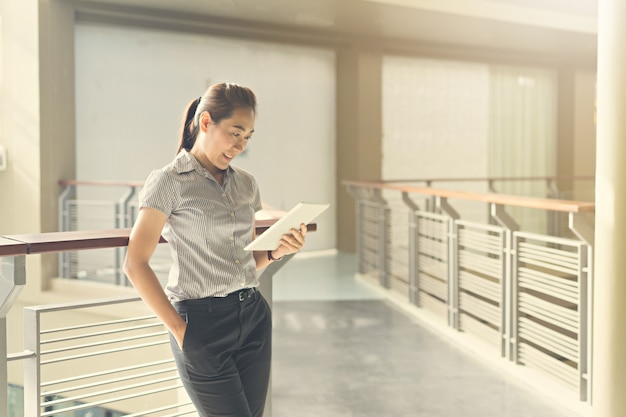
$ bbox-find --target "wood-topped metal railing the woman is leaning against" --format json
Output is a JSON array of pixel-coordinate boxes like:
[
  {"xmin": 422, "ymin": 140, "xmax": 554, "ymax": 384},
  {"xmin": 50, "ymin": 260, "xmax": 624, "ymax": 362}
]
[{"xmin": 0, "ymin": 218, "xmax": 300, "ymax": 417}]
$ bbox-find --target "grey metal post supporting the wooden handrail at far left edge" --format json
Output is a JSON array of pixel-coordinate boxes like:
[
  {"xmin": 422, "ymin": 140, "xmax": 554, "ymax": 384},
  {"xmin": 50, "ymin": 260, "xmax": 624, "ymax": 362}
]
[{"xmin": 0, "ymin": 255, "xmax": 26, "ymax": 415}]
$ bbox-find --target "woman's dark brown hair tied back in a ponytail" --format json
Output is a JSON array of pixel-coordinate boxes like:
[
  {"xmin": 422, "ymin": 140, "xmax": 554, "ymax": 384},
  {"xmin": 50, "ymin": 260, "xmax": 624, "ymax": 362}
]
[{"xmin": 176, "ymin": 83, "xmax": 256, "ymax": 153}]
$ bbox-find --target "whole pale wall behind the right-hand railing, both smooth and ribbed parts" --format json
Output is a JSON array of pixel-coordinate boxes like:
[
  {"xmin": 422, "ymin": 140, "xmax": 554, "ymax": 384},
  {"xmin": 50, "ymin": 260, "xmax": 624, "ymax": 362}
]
[{"xmin": 383, "ymin": 56, "xmax": 557, "ymax": 231}]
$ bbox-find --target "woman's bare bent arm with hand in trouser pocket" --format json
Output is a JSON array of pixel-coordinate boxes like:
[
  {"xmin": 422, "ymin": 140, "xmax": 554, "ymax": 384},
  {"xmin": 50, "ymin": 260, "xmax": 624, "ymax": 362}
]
[{"xmin": 124, "ymin": 207, "xmax": 187, "ymax": 348}]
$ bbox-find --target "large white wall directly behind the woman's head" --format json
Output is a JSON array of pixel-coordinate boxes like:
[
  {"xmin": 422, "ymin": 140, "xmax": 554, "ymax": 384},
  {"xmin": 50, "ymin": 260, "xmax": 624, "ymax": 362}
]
[{"xmin": 76, "ymin": 24, "xmax": 336, "ymax": 250}]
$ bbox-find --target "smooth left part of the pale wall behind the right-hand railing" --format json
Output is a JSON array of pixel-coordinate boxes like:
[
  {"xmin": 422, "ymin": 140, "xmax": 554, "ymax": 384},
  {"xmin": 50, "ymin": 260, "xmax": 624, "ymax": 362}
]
[{"xmin": 382, "ymin": 56, "xmax": 489, "ymax": 222}]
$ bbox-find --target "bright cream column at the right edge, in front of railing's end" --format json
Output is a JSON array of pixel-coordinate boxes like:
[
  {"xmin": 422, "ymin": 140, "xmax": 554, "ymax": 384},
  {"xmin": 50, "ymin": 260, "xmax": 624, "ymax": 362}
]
[{"xmin": 592, "ymin": 0, "xmax": 626, "ymax": 417}]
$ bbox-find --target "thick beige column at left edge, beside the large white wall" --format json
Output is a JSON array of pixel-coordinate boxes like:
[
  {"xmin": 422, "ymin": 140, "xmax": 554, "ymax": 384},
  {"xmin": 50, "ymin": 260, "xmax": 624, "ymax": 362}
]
[{"xmin": 0, "ymin": 0, "xmax": 75, "ymax": 292}]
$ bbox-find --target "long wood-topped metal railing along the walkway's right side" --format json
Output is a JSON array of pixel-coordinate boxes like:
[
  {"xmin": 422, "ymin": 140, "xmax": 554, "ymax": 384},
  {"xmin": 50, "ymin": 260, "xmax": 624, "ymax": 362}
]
[{"xmin": 344, "ymin": 181, "xmax": 595, "ymax": 401}]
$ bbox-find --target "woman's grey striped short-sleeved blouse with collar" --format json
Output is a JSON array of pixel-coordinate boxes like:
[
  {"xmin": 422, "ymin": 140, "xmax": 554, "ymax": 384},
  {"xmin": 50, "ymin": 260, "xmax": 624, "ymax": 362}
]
[{"xmin": 139, "ymin": 149, "xmax": 261, "ymax": 301}]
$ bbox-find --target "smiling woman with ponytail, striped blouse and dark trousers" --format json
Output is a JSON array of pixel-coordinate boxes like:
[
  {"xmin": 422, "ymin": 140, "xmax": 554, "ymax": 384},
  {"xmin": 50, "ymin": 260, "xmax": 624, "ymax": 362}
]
[{"xmin": 124, "ymin": 83, "xmax": 306, "ymax": 417}]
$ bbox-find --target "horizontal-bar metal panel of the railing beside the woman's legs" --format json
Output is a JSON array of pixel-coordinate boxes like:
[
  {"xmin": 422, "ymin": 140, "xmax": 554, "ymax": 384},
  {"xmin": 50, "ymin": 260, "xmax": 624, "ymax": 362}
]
[{"xmin": 17, "ymin": 297, "xmax": 195, "ymax": 417}]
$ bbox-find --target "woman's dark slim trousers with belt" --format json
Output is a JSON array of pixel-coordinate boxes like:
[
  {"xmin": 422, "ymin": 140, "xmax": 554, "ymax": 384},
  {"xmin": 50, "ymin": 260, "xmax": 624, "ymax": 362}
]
[{"xmin": 170, "ymin": 289, "xmax": 272, "ymax": 417}]
